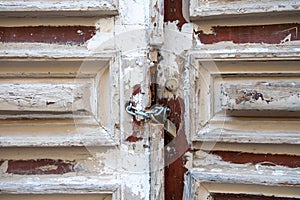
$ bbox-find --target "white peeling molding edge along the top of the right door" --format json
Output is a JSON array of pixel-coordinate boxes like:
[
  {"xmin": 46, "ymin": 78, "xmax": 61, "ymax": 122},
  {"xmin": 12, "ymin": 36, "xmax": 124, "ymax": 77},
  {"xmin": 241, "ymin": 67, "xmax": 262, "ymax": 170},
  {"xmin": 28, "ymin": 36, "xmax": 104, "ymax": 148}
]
[{"xmin": 190, "ymin": 0, "xmax": 300, "ymax": 20}]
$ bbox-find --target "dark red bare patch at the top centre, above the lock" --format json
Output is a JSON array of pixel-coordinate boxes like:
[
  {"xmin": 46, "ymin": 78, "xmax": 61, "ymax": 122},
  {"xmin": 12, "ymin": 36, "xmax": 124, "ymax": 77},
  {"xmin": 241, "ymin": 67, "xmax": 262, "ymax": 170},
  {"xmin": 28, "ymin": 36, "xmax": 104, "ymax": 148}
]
[{"xmin": 164, "ymin": 0, "xmax": 187, "ymax": 30}]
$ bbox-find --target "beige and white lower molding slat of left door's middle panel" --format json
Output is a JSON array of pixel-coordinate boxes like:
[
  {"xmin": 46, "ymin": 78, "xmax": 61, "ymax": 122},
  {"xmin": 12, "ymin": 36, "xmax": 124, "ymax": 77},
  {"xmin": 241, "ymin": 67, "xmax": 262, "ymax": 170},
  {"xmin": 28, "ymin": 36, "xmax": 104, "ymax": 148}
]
[{"xmin": 0, "ymin": 117, "xmax": 117, "ymax": 147}]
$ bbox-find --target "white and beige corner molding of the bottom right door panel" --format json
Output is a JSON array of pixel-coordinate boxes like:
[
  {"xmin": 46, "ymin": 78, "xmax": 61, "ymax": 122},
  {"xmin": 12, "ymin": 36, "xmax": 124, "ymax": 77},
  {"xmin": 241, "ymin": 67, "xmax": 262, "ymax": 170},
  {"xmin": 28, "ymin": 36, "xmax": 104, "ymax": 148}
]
[{"xmin": 185, "ymin": 151, "xmax": 300, "ymax": 200}]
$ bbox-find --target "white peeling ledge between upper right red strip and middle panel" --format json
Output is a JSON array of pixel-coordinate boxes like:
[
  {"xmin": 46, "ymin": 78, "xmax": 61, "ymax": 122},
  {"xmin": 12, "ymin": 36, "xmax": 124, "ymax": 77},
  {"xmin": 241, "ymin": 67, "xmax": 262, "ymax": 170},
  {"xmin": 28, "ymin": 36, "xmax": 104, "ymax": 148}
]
[{"xmin": 190, "ymin": 42, "xmax": 300, "ymax": 61}]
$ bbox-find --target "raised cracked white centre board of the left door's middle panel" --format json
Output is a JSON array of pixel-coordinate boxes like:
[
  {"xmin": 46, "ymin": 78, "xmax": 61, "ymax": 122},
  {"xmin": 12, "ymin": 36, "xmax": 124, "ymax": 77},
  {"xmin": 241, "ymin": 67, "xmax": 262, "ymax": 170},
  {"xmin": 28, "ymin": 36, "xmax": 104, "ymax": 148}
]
[{"xmin": 0, "ymin": 79, "xmax": 93, "ymax": 114}]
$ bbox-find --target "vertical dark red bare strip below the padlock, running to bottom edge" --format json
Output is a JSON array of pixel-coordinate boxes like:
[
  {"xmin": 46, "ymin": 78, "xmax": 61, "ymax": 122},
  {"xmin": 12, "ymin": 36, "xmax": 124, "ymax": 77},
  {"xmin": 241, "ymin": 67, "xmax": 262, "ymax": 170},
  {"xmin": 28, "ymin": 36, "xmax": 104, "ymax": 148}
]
[{"xmin": 159, "ymin": 97, "xmax": 189, "ymax": 200}]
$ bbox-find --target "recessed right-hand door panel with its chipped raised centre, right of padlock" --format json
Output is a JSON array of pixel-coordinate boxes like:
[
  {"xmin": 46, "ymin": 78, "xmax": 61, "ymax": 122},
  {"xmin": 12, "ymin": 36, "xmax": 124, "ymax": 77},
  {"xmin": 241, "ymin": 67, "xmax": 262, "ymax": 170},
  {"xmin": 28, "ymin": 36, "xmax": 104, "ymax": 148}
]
[{"xmin": 192, "ymin": 60, "xmax": 300, "ymax": 144}]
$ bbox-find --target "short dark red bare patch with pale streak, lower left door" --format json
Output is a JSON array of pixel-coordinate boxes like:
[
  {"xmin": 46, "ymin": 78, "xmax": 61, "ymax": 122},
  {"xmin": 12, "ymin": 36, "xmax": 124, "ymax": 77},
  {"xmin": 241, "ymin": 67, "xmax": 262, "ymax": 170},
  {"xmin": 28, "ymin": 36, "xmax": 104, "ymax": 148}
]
[{"xmin": 6, "ymin": 159, "xmax": 75, "ymax": 175}]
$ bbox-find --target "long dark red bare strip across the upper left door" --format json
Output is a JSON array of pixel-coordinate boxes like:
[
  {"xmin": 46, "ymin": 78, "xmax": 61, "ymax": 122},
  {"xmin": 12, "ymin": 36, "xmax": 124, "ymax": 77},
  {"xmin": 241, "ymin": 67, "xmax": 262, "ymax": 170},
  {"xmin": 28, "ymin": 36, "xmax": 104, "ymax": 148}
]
[{"xmin": 0, "ymin": 26, "xmax": 96, "ymax": 44}]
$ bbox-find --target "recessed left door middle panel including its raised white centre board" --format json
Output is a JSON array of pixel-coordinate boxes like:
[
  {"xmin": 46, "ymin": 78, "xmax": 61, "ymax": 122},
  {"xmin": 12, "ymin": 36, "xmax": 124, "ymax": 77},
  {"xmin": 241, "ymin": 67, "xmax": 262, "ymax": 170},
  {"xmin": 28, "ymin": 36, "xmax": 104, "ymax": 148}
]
[{"xmin": 0, "ymin": 58, "xmax": 114, "ymax": 147}]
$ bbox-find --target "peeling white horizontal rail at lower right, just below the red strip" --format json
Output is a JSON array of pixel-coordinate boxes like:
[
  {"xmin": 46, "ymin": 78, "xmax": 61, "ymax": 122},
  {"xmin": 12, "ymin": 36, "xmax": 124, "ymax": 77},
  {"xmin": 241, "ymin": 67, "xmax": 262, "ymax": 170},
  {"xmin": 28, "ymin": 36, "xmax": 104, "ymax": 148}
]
[{"xmin": 191, "ymin": 151, "xmax": 300, "ymax": 187}]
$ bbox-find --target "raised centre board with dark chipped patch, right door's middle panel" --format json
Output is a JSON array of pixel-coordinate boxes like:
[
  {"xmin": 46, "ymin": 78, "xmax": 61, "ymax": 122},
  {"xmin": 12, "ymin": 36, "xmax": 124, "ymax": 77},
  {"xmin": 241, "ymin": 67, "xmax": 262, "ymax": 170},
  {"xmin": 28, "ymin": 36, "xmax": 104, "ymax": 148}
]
[{"xmin": 220, "ymin": 80, "xmax": 300, "ymax": 116}]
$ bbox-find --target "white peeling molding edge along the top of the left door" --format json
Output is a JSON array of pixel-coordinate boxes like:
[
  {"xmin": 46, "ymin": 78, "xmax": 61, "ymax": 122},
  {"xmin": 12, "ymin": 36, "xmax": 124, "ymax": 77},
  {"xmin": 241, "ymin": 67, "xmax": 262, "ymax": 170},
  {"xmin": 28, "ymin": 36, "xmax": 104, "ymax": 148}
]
[{"xmin": 0, "ymin": 0, "xmax": 118, "ymax": 17}]
